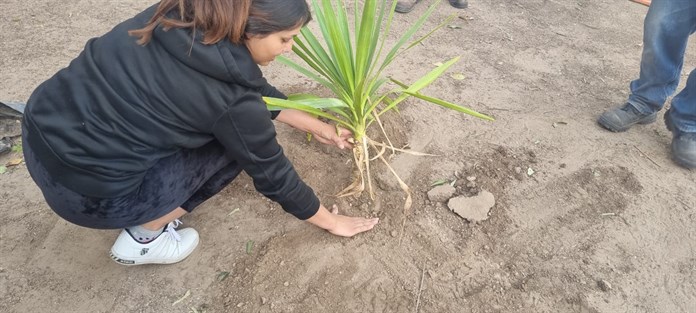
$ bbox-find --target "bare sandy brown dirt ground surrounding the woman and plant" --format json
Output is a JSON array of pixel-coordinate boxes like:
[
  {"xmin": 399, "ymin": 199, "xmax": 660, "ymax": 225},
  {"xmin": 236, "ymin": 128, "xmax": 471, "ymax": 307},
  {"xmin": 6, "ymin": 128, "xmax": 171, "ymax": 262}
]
[{"xmin": 0, "ymin": 0, "xmax": 696, "ymax": 312}]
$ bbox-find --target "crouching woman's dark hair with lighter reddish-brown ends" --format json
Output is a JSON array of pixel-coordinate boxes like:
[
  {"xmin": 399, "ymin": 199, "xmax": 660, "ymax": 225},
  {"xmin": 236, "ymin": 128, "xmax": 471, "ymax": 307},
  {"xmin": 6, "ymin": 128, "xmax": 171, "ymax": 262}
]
[{"xmin": 128, "ymin": 0, "xmax": 312, "ymax": 45}]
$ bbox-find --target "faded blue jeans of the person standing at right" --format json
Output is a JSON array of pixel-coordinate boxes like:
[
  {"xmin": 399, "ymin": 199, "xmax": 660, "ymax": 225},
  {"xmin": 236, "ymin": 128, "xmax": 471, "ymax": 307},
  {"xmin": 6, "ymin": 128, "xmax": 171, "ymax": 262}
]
[{"xmin": 628, "ymin": 0, "xmax": 696, "ymax": 133}]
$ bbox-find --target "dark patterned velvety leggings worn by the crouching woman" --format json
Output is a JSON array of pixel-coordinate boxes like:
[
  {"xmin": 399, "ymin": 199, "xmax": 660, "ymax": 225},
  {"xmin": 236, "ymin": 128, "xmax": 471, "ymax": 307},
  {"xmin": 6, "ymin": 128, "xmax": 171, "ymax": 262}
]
[{"xmin": 23, "ymin": 130, "xmax": 241, "ymax": 229}]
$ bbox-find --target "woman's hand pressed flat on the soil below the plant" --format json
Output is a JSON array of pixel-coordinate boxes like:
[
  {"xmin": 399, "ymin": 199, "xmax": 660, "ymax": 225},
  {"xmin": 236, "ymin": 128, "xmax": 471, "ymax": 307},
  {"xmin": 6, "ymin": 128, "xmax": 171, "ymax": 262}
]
[{"xmin": 307, "ymin": 205, "xmax": 379, "ymax": 237}]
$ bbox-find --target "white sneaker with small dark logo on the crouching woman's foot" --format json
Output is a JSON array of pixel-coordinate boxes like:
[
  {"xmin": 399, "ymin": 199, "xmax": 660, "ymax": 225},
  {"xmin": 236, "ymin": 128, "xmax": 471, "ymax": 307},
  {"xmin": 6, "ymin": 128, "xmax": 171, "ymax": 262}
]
[{"xmin": 111, "ymin": 219, "xmax": 198, "ymax": 265}]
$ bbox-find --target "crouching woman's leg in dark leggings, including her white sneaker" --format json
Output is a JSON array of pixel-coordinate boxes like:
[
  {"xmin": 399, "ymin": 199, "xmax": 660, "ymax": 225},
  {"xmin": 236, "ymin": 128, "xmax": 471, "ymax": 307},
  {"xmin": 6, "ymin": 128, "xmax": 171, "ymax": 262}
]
[{"xmin": 22, "ymin": 131, "xmax": 240, "ymax": 265}]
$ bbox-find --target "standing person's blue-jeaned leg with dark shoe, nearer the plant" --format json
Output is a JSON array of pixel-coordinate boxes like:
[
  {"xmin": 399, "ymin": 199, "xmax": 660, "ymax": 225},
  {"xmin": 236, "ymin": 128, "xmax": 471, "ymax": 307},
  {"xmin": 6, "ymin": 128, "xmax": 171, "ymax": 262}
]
[{"xmin": 598, "ymin": 0, "xmax": 696, "ymax": 132}]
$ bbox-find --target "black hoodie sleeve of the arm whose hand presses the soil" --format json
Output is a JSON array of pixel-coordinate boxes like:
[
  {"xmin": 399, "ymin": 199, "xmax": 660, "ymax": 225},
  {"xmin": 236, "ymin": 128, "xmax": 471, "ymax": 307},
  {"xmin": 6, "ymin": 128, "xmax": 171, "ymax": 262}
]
[{"xmin": 213, "ymin": 89, "xmax": 319, "ymax": 220}]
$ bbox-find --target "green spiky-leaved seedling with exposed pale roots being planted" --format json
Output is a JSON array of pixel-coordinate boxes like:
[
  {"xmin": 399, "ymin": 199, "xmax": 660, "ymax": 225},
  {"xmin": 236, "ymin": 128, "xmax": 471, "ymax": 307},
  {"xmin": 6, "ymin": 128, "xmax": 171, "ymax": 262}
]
[{"xmin": 265, "ymin": 0, "xmax": 493, "ymax": 209}]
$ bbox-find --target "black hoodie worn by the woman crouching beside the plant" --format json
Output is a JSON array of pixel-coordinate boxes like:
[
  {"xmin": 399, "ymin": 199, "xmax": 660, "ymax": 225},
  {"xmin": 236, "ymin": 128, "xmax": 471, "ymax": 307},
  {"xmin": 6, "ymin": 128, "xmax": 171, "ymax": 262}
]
[{"xmin": 24, "ymin": 6, "xmax": 319, "ymax": 219}]
